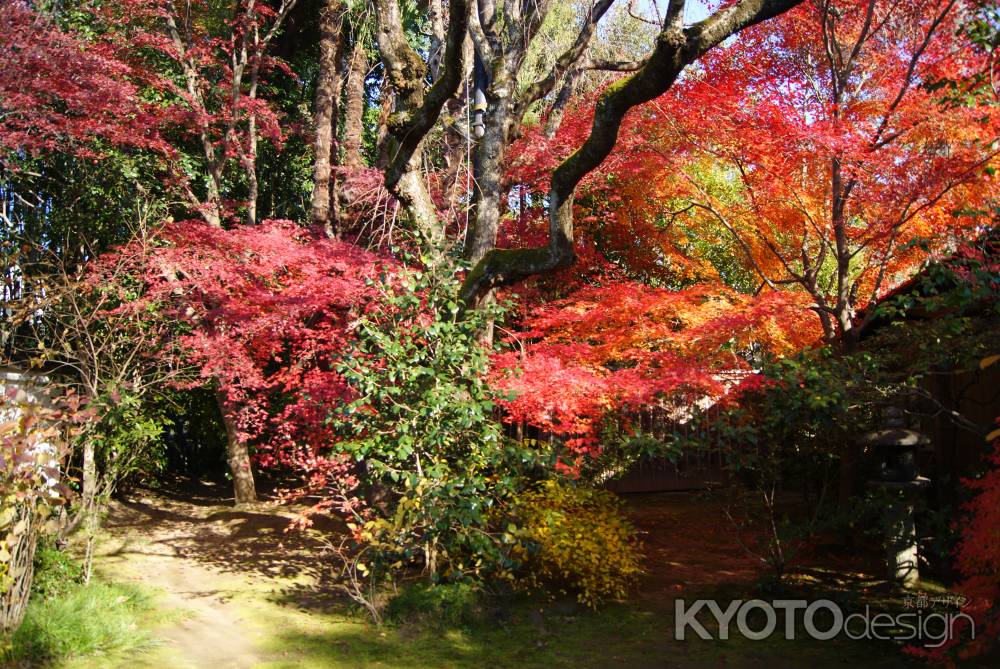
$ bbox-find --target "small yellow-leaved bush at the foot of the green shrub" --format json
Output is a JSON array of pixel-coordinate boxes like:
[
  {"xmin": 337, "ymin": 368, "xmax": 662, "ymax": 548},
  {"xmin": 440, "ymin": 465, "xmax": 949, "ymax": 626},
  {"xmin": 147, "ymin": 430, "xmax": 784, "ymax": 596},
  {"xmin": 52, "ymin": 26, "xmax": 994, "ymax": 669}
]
[{"xmin": 511, "ymin": 481, "xmax": 642, "ymax": 607}]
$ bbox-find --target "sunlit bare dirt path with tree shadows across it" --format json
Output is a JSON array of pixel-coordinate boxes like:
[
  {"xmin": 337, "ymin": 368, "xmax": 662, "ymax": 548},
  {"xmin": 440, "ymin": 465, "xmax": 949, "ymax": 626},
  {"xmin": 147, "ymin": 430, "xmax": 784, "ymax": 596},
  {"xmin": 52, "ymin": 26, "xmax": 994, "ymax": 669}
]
[{"xmin": 97, "ymin": 478, "xmax": 334, "ymax": 669}]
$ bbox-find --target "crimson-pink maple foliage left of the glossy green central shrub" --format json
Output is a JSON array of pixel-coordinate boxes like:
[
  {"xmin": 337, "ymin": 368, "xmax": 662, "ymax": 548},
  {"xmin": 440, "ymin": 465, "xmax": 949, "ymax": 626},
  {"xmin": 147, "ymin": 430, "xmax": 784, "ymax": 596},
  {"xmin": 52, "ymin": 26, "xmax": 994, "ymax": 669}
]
[{"xmin": 88, "ymin": 220, "xmax": 384, "ymax": 506}]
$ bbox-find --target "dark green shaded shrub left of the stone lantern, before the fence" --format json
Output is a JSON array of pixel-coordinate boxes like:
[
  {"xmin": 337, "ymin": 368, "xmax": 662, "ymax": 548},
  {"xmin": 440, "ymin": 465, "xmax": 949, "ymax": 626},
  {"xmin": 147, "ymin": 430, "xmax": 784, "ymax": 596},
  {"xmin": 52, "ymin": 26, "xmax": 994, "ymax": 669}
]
[{"xmin": 688, "ymin": 348, "xmax": 860, "ymax": 588}]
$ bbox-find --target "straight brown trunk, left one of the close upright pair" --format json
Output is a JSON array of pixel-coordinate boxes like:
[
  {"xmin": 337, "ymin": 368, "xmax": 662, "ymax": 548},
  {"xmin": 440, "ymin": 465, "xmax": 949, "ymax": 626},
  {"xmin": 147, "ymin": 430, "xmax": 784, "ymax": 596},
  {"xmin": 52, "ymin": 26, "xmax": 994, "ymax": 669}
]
[{"xmin": 312, "ymin": 0, "xmax": 344, "ymax": 236}]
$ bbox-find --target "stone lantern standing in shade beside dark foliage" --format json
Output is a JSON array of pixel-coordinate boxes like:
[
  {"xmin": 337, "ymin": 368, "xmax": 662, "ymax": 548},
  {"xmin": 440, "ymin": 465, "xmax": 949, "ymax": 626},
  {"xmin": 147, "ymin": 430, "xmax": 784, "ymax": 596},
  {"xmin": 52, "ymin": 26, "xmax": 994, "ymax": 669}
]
[{"xmin": 861, "ymin": 407, "xmax": 930, "ymax": 588}]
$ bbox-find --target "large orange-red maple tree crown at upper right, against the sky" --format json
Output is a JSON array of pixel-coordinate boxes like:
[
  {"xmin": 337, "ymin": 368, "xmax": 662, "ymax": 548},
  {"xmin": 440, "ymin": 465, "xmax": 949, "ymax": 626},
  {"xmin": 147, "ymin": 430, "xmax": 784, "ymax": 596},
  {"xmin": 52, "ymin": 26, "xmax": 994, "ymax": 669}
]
[{"xmin": 511, "ymin": 0, "xmax": 1000, "ymax": 340}]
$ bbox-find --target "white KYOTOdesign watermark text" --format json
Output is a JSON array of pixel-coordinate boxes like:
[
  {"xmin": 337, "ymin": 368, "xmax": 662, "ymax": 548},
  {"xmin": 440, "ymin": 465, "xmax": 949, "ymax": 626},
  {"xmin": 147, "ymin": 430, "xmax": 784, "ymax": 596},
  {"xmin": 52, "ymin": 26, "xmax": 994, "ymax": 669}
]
[{"xmin": 674, "ymin": 599, "xmax": 976, "ymax": 648}]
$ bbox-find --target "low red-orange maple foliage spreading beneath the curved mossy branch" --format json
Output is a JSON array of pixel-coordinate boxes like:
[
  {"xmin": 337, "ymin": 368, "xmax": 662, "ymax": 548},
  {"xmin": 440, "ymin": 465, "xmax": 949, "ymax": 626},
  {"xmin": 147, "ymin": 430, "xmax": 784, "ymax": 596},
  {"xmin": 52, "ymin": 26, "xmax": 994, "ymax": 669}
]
[{"xmin": 494, "ymin": 281, "xmax": 819, "ymax": 455}]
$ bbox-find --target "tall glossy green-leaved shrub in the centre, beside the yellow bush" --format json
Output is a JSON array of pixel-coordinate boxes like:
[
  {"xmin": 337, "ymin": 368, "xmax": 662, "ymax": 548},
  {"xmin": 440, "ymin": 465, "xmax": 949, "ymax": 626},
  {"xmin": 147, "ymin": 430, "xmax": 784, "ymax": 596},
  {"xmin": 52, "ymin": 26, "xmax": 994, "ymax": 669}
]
[{"xmin": 331, "ymin": 258, "xmax": 552, "ymax": 580}]
